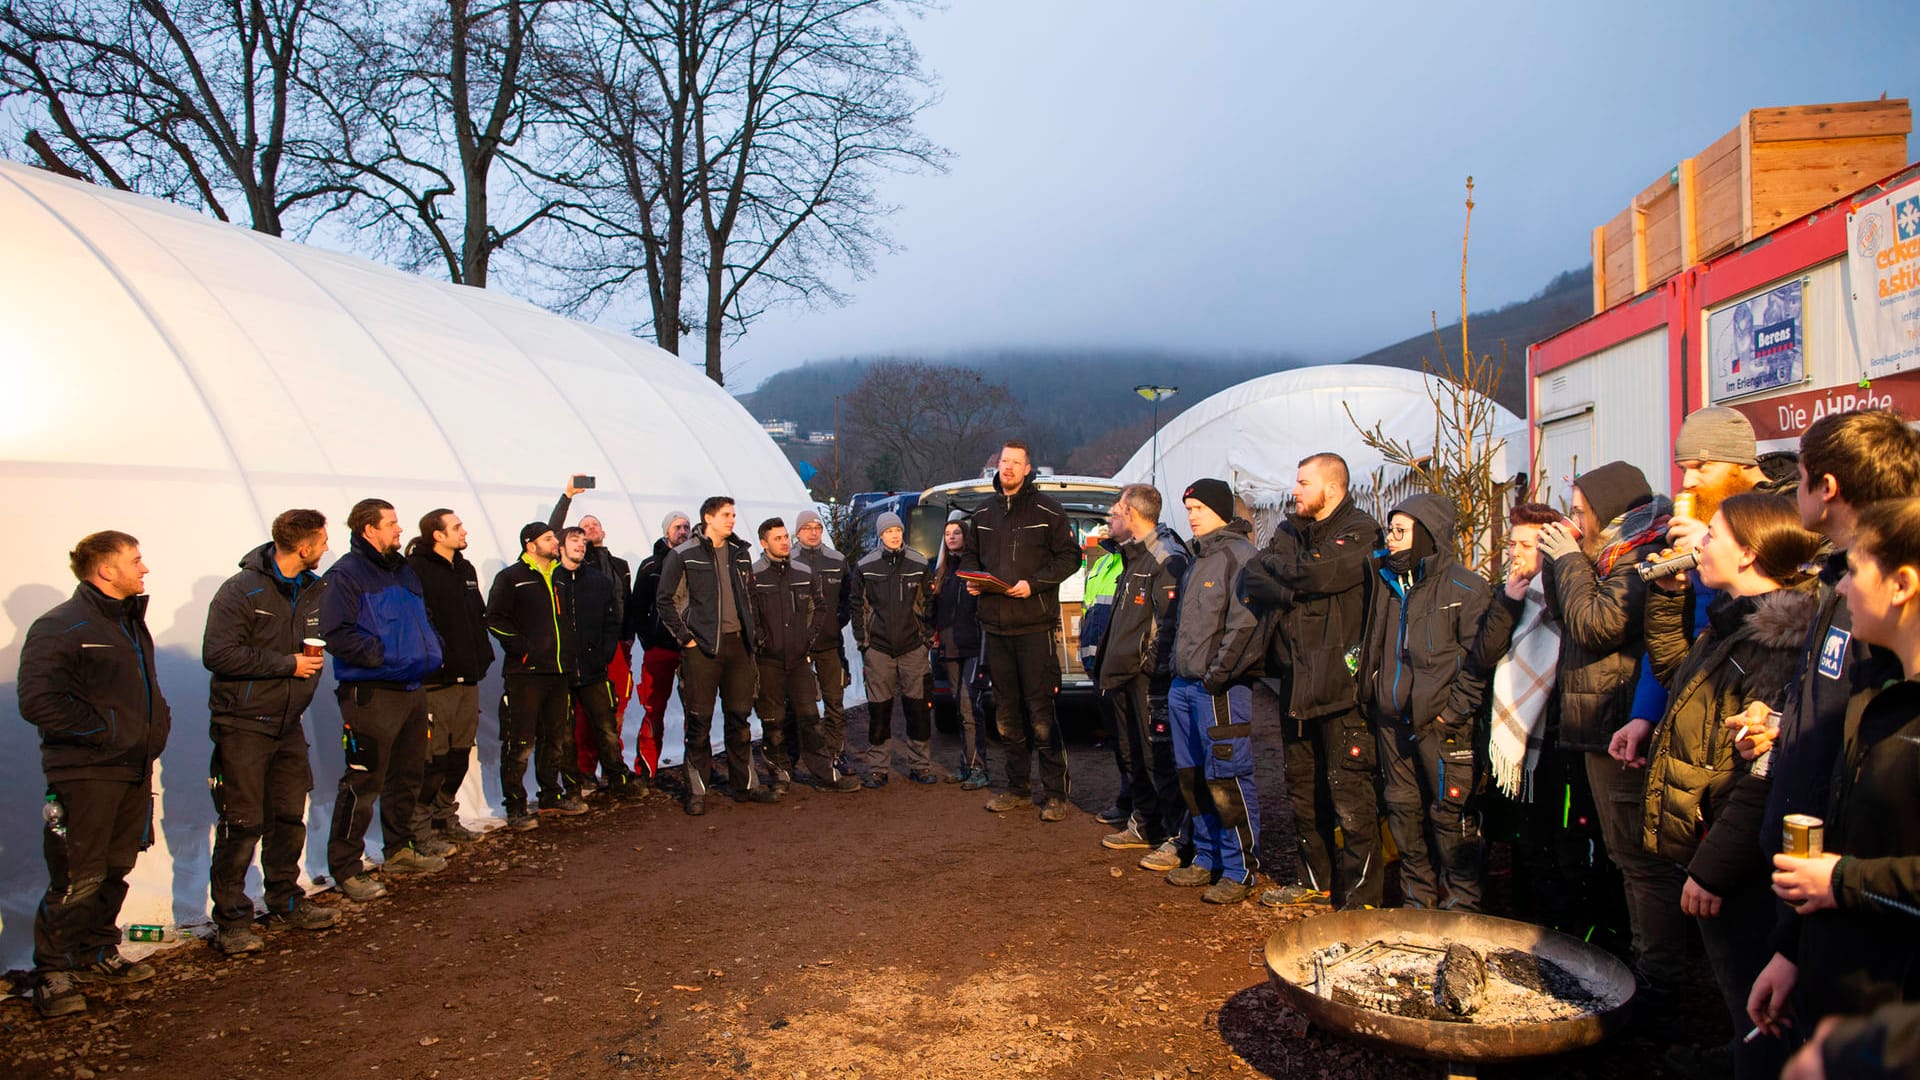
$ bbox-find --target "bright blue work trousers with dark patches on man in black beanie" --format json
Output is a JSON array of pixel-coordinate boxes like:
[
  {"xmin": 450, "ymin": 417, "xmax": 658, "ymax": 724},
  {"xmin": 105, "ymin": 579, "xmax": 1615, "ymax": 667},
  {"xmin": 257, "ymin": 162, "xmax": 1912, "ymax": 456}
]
[{"xmin": 1167, "ymin": 678, "xmax": 1260, "ymax": 882}]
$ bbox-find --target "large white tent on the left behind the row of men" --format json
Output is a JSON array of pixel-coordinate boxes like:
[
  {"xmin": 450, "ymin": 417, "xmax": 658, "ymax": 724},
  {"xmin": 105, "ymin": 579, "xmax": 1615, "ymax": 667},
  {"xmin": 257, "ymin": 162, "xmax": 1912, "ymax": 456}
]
[{"xmin": 0, "ymin": 163, "xmax": 812, "ymax": 963}]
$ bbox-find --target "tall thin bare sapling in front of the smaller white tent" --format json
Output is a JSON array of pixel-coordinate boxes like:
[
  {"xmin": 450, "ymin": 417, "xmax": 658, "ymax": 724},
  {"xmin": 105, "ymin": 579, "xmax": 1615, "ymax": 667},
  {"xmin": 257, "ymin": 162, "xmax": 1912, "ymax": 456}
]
[{"xmin": 1346, "ymin": 177, "xmax": 1507, "ymax": 577}]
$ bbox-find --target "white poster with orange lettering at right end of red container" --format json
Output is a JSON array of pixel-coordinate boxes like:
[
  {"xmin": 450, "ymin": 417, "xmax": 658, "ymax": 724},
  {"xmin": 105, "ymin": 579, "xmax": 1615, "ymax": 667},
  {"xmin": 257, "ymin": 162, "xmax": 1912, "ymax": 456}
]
[{"xmin": 1847, "ymin": 181, "xmax": 1920, "ymax": 377}]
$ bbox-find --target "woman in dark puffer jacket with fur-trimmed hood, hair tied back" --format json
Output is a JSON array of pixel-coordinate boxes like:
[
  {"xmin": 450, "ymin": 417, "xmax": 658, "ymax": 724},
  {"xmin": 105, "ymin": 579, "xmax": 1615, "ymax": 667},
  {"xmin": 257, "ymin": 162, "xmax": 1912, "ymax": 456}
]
[{"xmin": 1630, "ymin": 494, "xmax": 1820, "ymax": 1076}]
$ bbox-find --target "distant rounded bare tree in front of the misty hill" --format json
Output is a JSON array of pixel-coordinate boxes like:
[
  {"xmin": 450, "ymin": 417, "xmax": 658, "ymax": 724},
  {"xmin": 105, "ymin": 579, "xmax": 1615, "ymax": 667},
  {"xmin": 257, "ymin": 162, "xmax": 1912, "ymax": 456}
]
[{"xmin": 841, "ymin": 359, "xmax": 1023, "ymax": 490}]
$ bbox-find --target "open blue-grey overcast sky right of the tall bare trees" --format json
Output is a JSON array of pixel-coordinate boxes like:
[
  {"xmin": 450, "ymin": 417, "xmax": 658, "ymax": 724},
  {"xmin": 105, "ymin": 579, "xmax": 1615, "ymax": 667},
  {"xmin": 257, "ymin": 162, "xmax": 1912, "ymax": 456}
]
[{"xmin": 728, "ymin": 0, "xmax": 1920, "ymax": 388}]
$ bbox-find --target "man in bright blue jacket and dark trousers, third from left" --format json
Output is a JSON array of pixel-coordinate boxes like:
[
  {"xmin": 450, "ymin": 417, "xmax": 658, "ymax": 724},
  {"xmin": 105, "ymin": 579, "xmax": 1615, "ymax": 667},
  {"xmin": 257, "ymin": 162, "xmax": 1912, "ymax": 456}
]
[{"xmin": 319, "ymin": 500, "xmax": 447, "ymax": 901}]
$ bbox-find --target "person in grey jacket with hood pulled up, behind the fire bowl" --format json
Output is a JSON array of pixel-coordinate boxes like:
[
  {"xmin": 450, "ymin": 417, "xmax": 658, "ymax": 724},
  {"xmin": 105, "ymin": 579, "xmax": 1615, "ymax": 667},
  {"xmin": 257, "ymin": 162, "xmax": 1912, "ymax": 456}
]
[{"xmin": 1359, "ymin": 494, "xmax": 1492, "ymax": 911}]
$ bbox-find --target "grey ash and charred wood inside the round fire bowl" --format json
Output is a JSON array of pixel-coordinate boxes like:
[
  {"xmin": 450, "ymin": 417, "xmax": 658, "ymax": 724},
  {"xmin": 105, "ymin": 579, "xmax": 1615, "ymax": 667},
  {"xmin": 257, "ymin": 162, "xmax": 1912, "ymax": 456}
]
[{"xmin": 1300, "ymin": 938, "xmax": 1620, "ymax": 1026}]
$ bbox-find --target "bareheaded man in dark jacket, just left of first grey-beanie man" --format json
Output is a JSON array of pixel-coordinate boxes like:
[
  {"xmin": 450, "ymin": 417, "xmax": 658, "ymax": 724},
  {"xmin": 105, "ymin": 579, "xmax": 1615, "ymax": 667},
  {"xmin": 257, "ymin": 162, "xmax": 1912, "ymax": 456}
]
[{"xmin": 753, "ymin": 517, "xmax": 860, "ymax": 792}]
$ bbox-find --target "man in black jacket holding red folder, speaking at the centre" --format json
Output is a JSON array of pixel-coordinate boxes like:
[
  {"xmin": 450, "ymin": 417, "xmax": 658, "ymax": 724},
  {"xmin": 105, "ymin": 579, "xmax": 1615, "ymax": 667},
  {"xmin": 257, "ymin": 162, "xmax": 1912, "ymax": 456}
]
[{"xmin": 960, "ymin": 438, "xmax": 1081, "ymax": 821}]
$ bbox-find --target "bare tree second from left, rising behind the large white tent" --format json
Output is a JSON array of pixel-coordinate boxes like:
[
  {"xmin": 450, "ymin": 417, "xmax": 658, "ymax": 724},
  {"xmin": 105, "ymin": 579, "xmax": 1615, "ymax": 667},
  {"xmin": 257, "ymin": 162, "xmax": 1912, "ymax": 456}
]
[{"xmin": 303, "ymin": 0, "xmax": 580, "ymax": 288}]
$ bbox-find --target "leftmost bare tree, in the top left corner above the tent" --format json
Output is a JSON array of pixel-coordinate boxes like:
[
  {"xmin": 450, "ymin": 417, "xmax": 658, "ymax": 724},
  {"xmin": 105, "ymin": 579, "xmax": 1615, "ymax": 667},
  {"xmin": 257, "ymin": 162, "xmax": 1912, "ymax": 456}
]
[{"xmin": 0, "ymin": 0, "xmax": 340, "ymax": 236}]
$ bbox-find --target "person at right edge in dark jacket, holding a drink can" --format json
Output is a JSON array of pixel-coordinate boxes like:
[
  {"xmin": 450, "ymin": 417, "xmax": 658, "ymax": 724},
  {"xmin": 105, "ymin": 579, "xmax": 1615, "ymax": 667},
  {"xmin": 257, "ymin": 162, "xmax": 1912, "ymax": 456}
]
[{"xmin": 1747, "ymin": 498, "xmax": 1920, "ymax": 1036}]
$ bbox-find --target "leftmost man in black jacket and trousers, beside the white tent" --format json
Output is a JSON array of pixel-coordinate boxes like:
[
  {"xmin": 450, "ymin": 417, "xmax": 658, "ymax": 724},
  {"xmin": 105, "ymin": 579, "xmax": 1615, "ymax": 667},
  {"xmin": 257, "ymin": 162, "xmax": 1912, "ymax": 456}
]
[{"xmin": 17, "ymin": 530, "xmax": 173, "ymax": 1019}]
